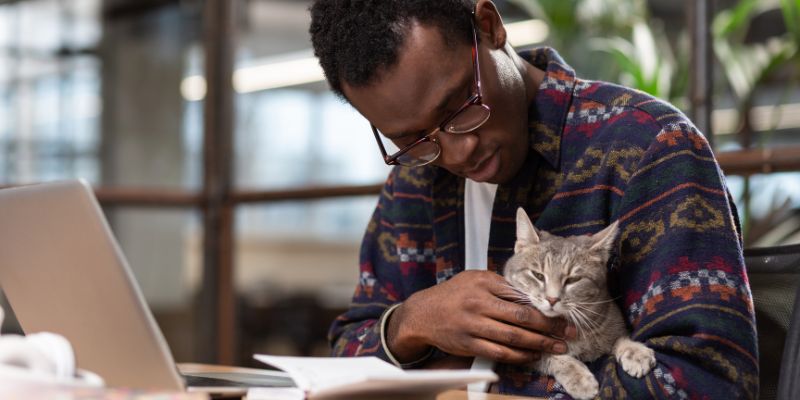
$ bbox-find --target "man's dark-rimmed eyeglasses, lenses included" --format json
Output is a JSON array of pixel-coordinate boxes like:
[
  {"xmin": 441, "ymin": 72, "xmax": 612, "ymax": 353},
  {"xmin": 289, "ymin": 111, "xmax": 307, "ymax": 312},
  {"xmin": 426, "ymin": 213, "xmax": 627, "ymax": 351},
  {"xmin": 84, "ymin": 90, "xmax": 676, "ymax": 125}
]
[{"xmin": 371, "ymin": 17, "xmax": 491, "ymax": 167}]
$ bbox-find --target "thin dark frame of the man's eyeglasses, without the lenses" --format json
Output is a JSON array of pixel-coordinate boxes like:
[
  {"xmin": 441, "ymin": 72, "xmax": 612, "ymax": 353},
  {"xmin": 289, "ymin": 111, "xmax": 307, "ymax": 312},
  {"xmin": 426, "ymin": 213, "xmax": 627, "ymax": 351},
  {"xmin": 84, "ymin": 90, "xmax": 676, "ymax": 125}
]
[{"xmin": 370, "ymin": 13, "xmax": 491, "ymax": 167}]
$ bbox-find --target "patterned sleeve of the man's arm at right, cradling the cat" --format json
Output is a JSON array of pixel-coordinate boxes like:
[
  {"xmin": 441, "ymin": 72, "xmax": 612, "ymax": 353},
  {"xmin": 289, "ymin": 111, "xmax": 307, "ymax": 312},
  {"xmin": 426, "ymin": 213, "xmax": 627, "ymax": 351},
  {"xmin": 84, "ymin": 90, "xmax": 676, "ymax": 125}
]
[{"xmin": 593, "ymin": 123, "xmax": 758, "ymax": 399}]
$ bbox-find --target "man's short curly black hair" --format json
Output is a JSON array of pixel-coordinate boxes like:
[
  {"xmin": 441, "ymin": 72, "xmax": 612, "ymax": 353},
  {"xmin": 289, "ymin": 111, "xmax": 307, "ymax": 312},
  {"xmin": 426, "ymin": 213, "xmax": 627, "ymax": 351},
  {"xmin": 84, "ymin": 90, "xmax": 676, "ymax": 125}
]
[{"xmin": 309, "ymin": 0, "xmax": 475, "ymax": 100}]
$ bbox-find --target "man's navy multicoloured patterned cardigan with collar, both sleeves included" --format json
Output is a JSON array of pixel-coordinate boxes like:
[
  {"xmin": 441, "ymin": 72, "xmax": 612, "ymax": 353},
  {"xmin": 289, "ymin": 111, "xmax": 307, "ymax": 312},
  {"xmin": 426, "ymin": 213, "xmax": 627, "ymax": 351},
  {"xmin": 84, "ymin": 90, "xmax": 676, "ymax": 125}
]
[{"xmin": 330, "ymin": 48, "xmax": 758, "ymax": 399}]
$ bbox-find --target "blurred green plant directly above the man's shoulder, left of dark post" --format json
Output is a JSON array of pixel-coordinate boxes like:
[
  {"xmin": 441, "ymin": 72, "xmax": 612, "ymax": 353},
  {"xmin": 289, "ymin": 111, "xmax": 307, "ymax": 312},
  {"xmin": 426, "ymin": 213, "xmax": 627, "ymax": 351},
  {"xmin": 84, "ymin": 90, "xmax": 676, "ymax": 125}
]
[{"xmin": 512, "ymin": 0, "xmax": 688, "ymax": 107}]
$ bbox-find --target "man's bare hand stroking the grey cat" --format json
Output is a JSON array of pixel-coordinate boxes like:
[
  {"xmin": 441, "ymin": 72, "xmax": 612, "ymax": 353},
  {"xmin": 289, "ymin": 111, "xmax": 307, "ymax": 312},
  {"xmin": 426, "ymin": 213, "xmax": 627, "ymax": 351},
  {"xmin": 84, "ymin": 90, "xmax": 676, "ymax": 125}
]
[{"xmin": 386, "ymin": 271, "xmax": 575, "ymax": 364}]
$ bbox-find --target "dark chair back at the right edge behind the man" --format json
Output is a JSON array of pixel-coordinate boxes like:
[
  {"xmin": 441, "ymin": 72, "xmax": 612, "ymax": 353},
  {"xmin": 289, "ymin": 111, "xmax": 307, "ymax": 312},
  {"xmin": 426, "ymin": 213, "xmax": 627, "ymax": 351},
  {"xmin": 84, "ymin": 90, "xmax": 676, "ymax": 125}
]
[{"xmin": 744, "ymin": 244, "xmax": 800, "ymax": 400}]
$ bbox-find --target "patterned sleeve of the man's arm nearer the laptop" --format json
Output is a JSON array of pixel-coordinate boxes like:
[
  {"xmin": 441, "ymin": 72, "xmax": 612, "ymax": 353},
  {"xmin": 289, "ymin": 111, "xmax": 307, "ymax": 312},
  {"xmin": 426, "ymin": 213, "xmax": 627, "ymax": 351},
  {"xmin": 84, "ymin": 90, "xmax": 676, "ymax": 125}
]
[{"xmin": 328, "ymin": 169, "xmax": 401, "ymax": 362}]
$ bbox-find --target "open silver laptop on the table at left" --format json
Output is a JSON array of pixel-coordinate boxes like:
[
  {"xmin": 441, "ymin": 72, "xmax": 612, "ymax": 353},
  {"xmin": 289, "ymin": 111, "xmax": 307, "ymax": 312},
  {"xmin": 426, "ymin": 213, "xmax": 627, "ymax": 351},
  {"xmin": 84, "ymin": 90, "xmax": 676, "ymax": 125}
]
[{"xmin": 0, "ymin": 180, "xmax": 294, "ymax": 393}]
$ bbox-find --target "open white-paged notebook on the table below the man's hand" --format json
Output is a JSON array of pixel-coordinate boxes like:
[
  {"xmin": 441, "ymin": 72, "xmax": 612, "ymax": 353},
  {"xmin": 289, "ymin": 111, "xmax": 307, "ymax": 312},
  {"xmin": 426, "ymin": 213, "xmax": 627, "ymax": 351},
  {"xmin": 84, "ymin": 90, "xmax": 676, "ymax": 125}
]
[{"xmin": 253, "ymin": 354, "xmax": 497, "ymax": 399}]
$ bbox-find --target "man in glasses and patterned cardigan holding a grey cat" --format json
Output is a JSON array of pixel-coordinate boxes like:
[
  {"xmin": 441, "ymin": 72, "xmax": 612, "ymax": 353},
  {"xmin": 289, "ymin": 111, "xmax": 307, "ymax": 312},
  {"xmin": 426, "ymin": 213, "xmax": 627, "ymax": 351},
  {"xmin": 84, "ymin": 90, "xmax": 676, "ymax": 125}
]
[{"xmin": 310, "ymin": 0, "xmax": 758, "ymax": 398}]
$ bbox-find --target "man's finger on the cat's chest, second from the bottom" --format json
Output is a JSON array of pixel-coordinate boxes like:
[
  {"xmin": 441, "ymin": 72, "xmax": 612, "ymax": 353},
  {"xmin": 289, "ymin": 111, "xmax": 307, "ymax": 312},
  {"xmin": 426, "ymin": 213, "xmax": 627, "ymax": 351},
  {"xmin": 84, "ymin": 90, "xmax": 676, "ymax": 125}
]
[{"xmin": 478, "ymin": 318, "xmax": 567, "ymax": 354}]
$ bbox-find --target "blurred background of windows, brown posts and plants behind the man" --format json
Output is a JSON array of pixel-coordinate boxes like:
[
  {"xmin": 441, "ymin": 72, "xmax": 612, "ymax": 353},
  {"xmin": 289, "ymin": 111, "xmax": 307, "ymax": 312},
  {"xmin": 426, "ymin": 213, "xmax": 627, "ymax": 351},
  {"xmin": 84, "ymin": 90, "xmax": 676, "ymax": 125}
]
[{"xmin": 0, "ymin": 0, "xmax": 800, "ymax": 365}]
